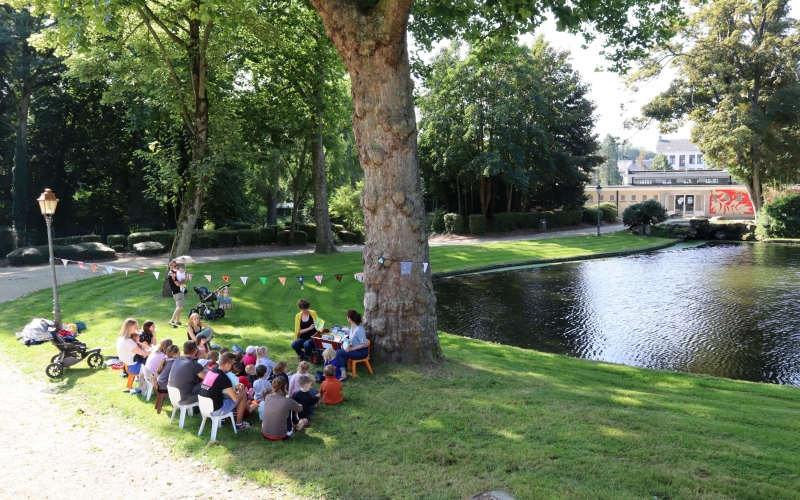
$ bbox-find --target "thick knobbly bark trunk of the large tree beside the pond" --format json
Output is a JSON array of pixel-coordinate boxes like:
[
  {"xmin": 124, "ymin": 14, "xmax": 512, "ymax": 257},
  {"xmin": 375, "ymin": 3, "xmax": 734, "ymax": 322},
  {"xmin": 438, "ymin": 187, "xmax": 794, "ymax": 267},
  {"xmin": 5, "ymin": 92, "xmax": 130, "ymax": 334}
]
[{"xmin": 312, "ymin": 0, "xmax": 442, "ymax": 363}]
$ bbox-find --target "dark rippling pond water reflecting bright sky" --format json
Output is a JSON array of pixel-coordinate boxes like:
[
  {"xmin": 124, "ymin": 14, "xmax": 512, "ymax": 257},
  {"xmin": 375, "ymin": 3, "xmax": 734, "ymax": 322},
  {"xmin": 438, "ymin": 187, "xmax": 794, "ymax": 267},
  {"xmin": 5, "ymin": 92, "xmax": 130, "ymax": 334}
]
[{"xmin": 434, "ymin": 244, "xmax": 800, "ymax": 385}]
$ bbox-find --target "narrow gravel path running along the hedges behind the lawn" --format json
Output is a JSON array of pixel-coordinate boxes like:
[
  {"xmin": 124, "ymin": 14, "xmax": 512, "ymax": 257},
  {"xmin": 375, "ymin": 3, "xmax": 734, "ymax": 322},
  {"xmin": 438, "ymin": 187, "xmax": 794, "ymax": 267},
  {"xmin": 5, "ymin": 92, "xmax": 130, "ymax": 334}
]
[{"xmin": 0, "ymin": 224, "xmax": 622, "ymax": 303}]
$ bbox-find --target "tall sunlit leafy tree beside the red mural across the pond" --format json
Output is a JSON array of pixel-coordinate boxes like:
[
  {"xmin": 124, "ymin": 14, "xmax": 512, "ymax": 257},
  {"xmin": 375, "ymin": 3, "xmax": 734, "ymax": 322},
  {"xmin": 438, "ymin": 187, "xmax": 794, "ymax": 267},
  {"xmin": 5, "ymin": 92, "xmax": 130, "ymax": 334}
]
[{"xmin": 632, "ymin": 0, "xmax": 800, "ymax": 211}]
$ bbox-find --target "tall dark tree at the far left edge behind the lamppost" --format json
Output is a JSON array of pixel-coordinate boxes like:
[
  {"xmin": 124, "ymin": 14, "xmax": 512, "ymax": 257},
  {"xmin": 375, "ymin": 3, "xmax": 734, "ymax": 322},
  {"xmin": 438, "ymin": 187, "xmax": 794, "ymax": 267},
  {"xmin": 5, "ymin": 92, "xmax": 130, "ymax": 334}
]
[{"xmin": 0, "ymin": 3, "xmax": 60, "ymax": 242}]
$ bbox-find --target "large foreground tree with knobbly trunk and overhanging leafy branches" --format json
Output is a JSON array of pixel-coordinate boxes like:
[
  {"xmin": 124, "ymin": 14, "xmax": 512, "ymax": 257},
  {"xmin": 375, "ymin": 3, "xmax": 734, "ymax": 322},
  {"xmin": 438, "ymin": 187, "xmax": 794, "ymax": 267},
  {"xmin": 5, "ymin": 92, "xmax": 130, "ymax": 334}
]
[{"xmin": 311, "ymin": 0, "xmax": 680, "ymax": 362}]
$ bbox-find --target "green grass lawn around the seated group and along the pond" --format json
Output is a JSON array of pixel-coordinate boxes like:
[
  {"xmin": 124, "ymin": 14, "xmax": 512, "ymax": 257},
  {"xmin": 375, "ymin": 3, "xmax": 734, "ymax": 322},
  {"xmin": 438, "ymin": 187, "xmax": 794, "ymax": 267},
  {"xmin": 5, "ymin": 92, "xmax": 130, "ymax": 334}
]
[{"xmin": 0, "ymin": 234, "xmax": 800, "ymax": 499}]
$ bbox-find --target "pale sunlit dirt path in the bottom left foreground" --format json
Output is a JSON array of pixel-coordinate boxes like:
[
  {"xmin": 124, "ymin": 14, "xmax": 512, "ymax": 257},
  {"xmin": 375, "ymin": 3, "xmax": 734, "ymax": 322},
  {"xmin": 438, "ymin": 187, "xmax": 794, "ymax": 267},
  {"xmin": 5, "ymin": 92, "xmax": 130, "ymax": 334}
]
[{"xmin": 0, "ymin": 358, "xmax": 296, "ymax": 500}]
